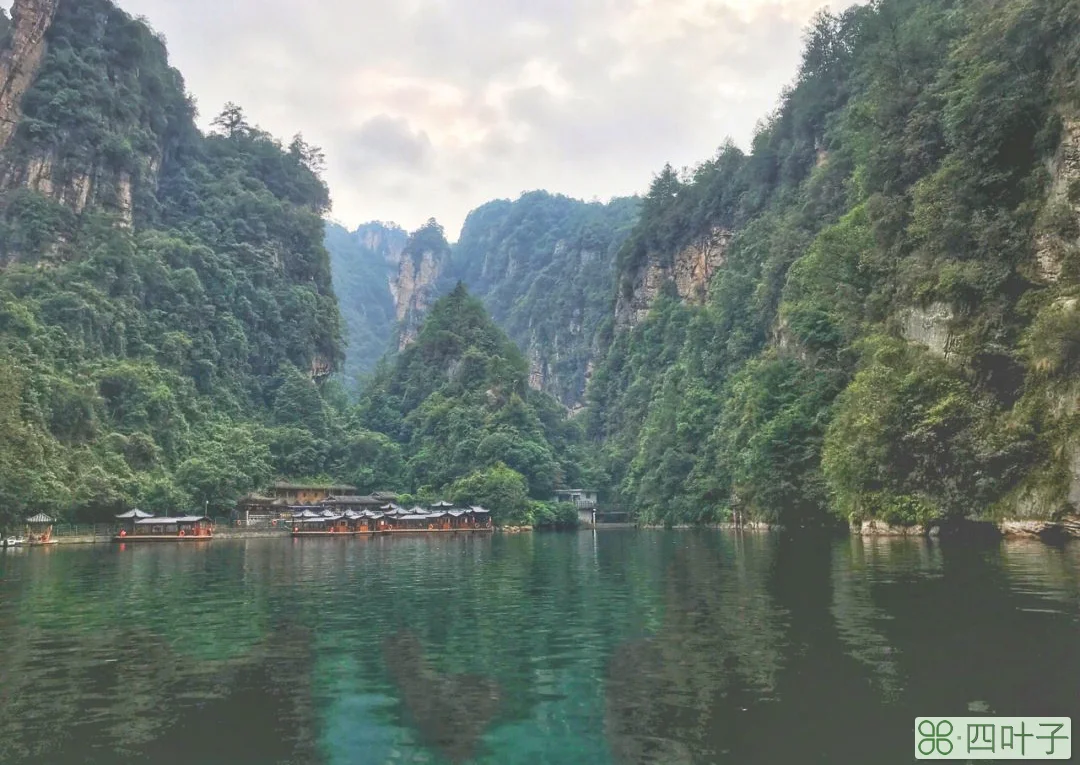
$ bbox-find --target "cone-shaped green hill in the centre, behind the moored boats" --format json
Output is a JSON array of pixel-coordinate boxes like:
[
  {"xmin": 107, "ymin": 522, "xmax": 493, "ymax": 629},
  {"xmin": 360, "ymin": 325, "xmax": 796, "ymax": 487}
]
[{"xmin": 356, "ymin": 283, "xmax": 594, "ymax": 529}]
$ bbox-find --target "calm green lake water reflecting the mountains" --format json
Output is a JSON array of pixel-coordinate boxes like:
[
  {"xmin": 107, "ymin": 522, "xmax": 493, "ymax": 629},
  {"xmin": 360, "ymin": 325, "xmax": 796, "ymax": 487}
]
[{"xmin": 0, "ymin": 531, "xmax": 1080, "ymax": 765}]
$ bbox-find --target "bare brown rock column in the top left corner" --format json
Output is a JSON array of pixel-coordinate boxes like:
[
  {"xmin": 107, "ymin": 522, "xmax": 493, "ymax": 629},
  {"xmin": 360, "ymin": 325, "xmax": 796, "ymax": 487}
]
[{"xmin": 0, "ymin": 0, "xmax": 59, "ymax": 150}]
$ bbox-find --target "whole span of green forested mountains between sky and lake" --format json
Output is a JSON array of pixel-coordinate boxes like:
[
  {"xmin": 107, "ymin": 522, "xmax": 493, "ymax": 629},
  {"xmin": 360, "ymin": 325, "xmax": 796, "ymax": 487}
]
[{"xmin": 0, "ymin": 0, "xmax": 1080, "ymax": 535}]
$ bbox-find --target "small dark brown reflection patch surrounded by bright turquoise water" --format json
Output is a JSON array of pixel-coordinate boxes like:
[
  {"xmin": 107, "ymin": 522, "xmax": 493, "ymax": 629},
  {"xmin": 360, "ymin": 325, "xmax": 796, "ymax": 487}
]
[{"xmin": 382, "ymin": 632, "xmax": 501, "ymax": 763}]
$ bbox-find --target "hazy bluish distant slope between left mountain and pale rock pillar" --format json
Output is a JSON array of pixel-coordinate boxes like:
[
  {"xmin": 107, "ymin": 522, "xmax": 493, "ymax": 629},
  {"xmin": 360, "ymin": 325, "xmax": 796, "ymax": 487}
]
[{"xmin": 325, "ymin": 223, "xmax": 408, "ymax": 390}]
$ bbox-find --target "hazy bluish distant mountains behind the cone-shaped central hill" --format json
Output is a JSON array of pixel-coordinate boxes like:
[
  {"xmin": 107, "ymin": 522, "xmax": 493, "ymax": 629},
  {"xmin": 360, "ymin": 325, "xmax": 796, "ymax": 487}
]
[{"xmin": 326, "ymin": 191, "xmax": 638, "ymax": 407}]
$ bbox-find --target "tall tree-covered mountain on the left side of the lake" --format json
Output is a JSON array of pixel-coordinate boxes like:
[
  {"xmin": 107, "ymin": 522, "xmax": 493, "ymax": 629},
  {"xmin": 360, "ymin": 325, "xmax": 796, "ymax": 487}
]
[{"xmin": 0, "ymin": 0, "xmax": 348, "ymax": 525}]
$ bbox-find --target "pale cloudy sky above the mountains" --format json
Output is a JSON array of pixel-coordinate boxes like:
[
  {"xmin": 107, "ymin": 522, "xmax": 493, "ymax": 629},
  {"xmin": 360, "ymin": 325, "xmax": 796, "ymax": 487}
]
[{"xmin": 95, "ymin": 0, "xmax": 846, "ymax": 239}]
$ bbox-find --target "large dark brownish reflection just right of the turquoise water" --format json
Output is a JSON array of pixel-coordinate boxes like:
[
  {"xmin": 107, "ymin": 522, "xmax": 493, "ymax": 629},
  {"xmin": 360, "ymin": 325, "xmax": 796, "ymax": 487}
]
[{"xmin": 605, "ymin": 535, "xmax": 783, "ymax": 765}]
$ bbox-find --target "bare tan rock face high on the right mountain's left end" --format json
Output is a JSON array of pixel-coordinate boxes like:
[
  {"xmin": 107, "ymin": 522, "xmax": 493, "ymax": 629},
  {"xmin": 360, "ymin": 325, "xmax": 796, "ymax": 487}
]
[{"xmin": 615, "ymin": 227, "xmax": 732, "ymax": 328}]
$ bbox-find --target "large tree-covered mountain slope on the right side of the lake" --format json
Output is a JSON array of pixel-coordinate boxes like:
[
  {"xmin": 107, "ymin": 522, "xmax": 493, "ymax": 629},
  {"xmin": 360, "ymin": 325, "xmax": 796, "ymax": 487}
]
[{"xmin": 589, "ymin": 0, "xmax": 1080, "ymax": 525}]
